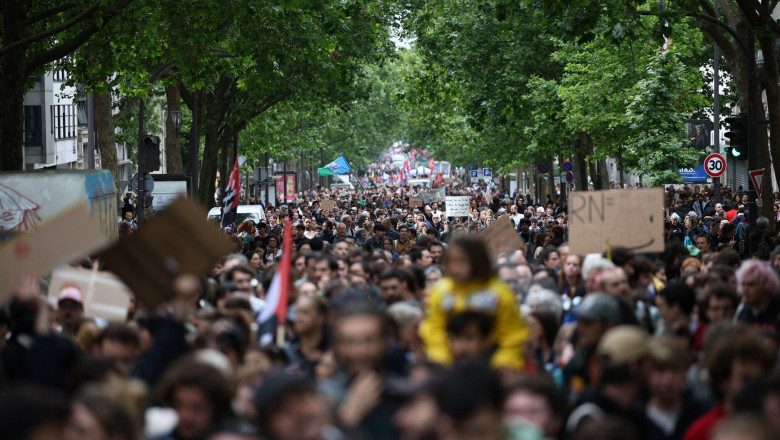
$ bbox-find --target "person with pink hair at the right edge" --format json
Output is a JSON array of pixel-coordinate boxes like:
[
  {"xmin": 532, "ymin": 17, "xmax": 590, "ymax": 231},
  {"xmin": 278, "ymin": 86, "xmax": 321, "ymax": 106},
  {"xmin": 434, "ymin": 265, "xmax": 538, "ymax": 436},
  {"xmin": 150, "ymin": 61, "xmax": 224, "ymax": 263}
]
[{"xmin": 736, "ymin": 260, "xmax": 780, "ymax": 332}]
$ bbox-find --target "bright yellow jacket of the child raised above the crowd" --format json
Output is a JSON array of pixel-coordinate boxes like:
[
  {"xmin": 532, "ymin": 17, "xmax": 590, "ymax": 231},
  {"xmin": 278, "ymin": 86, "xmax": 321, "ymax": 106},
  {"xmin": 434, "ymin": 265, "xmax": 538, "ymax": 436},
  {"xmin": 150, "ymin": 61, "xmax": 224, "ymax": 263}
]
[{"xmin": 420, "ymin": 278, "xmax": 529, "ymax": 370}]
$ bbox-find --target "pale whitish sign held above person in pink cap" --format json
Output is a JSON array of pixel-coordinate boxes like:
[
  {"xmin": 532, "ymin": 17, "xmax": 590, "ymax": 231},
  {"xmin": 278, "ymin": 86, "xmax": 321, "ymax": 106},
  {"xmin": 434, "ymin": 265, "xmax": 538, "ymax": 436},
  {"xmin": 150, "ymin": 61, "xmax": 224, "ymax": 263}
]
[{"xmin": 49, "ymin": 266, "xmax": 132, "ymax": 322}]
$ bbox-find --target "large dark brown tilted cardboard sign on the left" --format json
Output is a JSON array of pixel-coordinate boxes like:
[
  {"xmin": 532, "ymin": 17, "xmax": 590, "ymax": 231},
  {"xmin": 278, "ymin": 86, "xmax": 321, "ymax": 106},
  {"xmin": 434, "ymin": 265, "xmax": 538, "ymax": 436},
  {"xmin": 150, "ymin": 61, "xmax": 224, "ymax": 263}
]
[{"xmin": 99, "ymin": 197, "xmax": 235, "ymax": 307}]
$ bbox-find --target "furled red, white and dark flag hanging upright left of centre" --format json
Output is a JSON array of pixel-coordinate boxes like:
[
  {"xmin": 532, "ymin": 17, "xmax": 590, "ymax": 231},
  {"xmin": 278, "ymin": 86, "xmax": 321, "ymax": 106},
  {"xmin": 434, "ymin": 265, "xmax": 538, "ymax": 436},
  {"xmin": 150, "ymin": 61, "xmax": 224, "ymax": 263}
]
[{"xmin": 257, "ymin": 218, "xmax": 292, "ymax": 346}]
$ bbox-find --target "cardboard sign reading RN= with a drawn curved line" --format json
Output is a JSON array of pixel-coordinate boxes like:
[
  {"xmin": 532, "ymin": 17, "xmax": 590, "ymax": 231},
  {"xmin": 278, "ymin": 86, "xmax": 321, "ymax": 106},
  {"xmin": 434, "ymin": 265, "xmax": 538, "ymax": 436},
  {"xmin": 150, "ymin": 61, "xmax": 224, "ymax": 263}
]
[{"xmin": 569, "ymin": 188, "xmax": 664, "ymax": 255}]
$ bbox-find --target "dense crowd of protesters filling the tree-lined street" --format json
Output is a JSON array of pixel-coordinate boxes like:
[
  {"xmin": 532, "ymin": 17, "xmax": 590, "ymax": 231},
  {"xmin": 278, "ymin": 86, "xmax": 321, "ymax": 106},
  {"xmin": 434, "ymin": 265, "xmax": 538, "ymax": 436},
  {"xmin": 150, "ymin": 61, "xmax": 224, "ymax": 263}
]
[{"xmin": 0, "ymin": 175, "xmax": 780, "ymax": 440}]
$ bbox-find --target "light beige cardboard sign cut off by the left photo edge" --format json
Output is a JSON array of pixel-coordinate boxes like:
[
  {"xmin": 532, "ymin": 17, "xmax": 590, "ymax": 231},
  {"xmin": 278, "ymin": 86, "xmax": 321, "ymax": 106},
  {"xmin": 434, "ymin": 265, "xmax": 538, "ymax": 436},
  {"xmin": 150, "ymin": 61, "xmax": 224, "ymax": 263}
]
[{"xmin": 0, "ymin": 204, "xmax": 106, "ymax": 302}]
